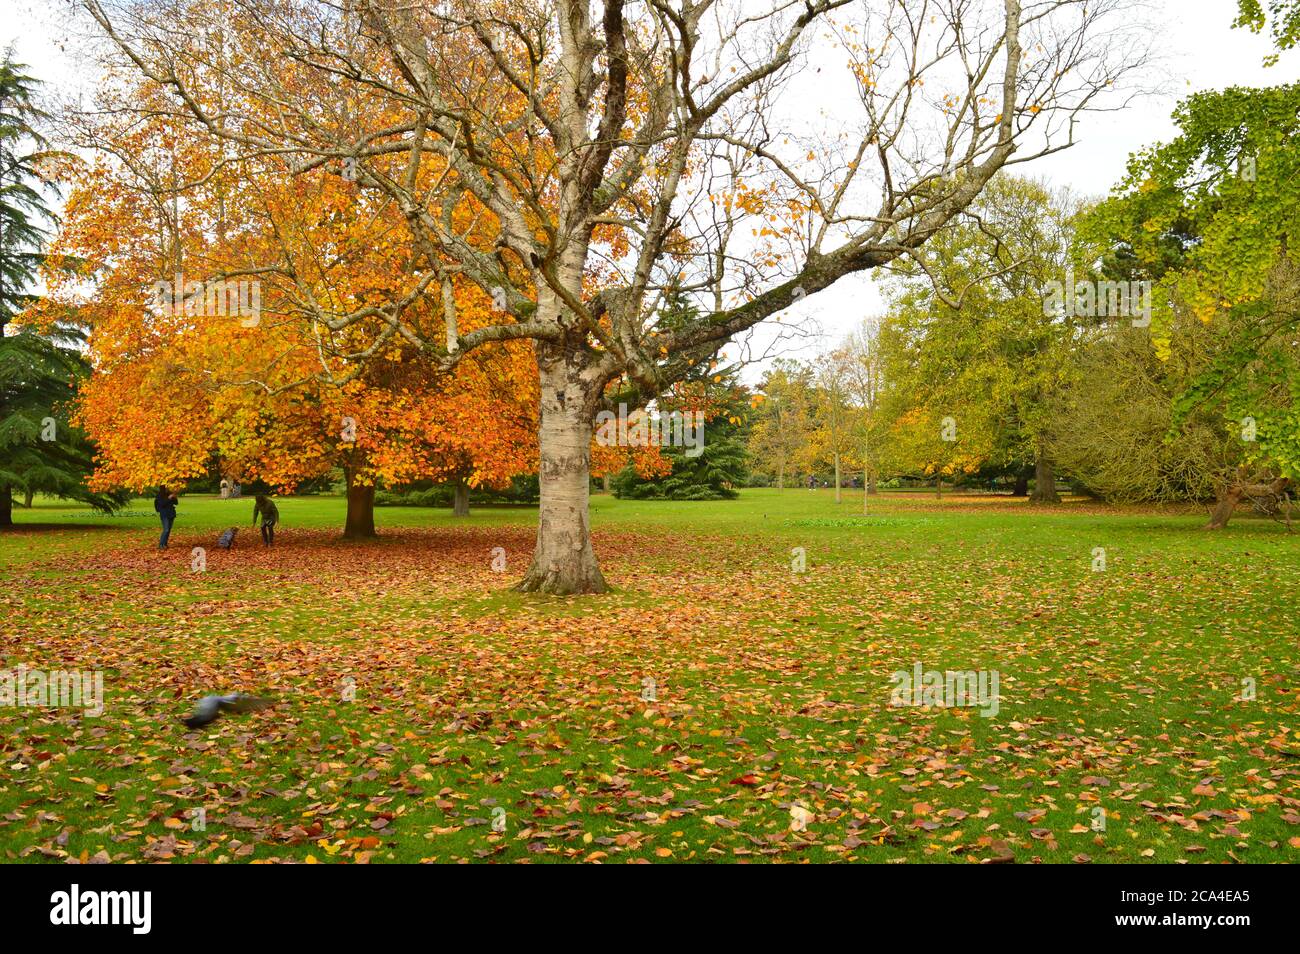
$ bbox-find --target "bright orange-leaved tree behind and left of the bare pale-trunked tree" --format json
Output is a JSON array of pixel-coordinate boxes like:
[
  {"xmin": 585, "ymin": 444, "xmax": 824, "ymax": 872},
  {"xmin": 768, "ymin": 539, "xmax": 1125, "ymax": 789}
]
[{"xmin": 48, "ymin": 71, "xmax": 536, "ymax": 538}]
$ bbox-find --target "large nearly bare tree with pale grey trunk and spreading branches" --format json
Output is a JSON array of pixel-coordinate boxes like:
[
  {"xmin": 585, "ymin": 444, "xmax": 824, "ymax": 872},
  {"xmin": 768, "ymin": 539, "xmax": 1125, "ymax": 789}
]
[{"xmin": 83, "ymin": 0, "xmax": 1144, "ymax": 593}]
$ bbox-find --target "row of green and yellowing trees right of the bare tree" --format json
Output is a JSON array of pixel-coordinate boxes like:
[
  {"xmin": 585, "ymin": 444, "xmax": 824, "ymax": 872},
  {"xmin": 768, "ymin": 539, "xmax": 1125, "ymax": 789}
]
[{"xmin": 749, "ymin": 115, "xmax": 1300, "ymax": 528}]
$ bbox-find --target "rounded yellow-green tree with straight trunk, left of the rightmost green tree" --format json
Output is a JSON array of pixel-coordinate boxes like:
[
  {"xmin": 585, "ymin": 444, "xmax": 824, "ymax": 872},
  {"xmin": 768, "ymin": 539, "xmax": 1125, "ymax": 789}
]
[{"xmin": 889, "ymin": 175, "xmax": 1081, "ymax": 503}]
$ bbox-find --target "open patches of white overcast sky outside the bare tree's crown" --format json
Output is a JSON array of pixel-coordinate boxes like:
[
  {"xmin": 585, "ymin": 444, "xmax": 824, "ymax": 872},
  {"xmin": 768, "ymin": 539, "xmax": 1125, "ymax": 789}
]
[{"xmin": 0, "ymin": 0, "xmax": 1300, "ymax": 380}]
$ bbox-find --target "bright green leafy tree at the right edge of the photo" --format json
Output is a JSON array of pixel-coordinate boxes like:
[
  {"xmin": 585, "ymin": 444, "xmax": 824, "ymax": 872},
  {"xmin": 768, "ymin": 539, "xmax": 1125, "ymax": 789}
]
[{"xmin": 1086, "ymin": 83, "xmax": 1300, "ymax": 529}]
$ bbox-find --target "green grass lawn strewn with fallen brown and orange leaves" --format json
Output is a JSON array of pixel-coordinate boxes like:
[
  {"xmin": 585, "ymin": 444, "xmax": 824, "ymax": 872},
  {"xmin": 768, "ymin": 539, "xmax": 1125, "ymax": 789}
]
[{"xmin": 0, "ymin": 489, "xmax": 1300, "ymax": 863}]
